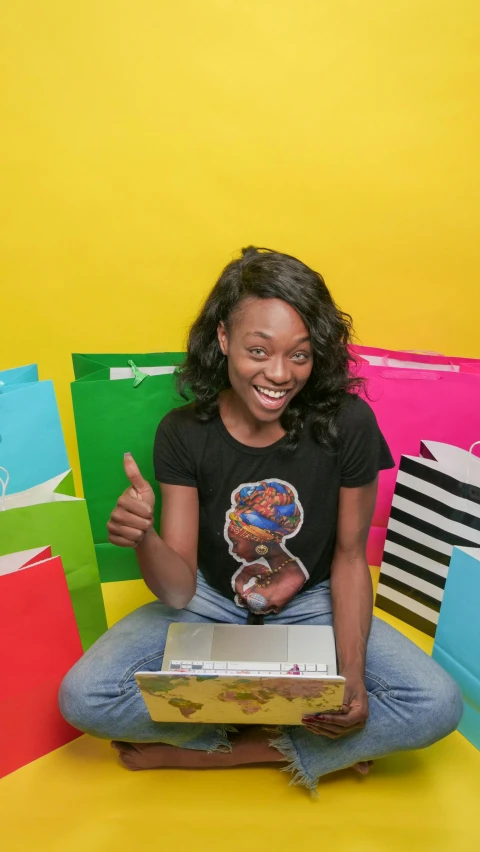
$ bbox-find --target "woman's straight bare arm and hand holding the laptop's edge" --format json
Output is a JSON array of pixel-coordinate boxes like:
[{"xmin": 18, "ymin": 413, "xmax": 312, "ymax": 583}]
[{"xmin": 304, "ymin": 479, "xmax": 377, "ymax": 738}]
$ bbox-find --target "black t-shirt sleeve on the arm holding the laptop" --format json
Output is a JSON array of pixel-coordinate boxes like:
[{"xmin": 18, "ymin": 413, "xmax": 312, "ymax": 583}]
[{"xmin": 340, "ymin": 395, "xmax": 395, "ymax": 488}]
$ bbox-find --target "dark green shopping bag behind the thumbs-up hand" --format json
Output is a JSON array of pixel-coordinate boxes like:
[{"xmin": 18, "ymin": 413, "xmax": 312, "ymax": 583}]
[{"xmin": 72, "ymin": 352, "xmax": 185, "ymax": 581}]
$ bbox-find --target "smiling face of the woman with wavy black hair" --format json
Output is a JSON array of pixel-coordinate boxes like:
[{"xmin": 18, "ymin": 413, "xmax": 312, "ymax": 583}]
[{"xmin": 218, "ymin": 298, "xmax": 313, "ymax": 423}]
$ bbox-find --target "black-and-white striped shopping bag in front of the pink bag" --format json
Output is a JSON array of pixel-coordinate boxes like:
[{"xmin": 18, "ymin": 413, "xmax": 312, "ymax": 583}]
[{"xmin": 375, "ymin": 441, "xmax": 480, "ymax": 636}]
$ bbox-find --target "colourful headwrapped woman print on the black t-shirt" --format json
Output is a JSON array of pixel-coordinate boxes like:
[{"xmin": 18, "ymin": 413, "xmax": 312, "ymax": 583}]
[{"xmin": 224, "ymin": 479, "xmax": 309, "ymax": 614}]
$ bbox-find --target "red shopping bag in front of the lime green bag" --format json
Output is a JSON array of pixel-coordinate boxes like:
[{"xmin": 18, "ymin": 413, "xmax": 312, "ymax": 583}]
[{"xmin": 0, "ymin": 547, "xmax": 82, "ymax": 777}]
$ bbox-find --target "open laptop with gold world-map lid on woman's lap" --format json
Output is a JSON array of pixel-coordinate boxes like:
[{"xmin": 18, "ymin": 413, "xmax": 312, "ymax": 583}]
[{"xmin": 135, "ymin": 624, "xmax": 345, "ymax": 725}]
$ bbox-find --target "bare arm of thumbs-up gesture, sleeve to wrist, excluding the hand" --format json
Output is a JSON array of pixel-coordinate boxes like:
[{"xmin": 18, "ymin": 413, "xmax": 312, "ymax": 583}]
[{"xmin": 135, "ymin": 484, "xmax": 198, "ymax": 609}]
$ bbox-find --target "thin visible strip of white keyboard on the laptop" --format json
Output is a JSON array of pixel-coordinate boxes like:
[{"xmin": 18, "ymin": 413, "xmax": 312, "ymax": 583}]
[{"xmin": 170, "ymin": 660, "xmax": 328, "ymax": 677}]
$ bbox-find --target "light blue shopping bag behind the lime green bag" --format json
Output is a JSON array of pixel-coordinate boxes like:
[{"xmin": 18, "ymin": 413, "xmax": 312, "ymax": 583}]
[{"xmin": 0, "ymin": 364, "xmax": 69, "ymax": 494}]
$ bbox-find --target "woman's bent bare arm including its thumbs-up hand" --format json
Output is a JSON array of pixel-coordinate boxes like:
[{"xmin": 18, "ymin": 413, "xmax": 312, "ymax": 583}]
[{"xmin": 107, "ymin": 453, "xmax": 198, "ymax": 609}]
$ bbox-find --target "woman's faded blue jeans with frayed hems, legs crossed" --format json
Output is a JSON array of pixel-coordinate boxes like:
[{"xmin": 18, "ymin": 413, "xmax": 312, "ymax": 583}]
[{"xmin": 60, "ymin": 574, "xmax": 463, "ymax": 789}]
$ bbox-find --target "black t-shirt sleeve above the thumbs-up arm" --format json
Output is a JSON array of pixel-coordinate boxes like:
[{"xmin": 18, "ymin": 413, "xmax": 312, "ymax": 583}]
[{"xmin": 153, "ymin": 409, "xmax": 197, "ymax": 487}]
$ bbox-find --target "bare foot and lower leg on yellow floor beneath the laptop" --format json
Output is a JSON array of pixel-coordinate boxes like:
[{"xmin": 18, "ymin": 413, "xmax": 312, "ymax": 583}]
[{"xmin": 112, "ymin": 727, "xmax": 285, "ymax": 771}]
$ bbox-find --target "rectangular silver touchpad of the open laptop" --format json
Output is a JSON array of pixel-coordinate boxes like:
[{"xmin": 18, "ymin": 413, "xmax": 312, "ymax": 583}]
[{"xmin": 211, "ymin": 624, "xmax": 288, "ymax": 663}]
